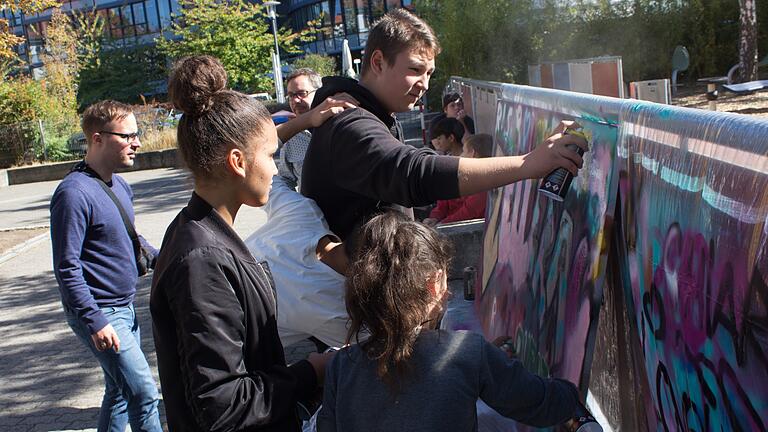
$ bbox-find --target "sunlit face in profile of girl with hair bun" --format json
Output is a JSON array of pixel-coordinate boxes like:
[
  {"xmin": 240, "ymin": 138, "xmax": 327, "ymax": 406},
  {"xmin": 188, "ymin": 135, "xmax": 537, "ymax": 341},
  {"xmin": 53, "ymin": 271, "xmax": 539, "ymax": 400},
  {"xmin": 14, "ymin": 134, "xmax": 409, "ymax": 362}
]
[{"xmin": 243, "ymin": 121, "xmax": 277, "ymax": 207}]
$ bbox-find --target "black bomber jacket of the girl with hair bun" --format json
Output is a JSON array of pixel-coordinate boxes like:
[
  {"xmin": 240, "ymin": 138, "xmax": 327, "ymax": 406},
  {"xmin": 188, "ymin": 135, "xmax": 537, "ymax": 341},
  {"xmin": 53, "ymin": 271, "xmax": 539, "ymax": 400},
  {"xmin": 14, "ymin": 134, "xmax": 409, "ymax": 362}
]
[{"xmin": 150, "ymin": 193, "xmax": 317, "ymax": 432}]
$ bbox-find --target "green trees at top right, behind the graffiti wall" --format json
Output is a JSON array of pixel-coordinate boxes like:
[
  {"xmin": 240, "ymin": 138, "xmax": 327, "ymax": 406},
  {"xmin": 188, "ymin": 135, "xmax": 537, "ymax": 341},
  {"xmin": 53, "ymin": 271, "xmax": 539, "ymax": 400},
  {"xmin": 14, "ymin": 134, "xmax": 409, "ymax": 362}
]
[{"xmin": 416, "ymin": 0, "xmax": 748, "ymax": 96}]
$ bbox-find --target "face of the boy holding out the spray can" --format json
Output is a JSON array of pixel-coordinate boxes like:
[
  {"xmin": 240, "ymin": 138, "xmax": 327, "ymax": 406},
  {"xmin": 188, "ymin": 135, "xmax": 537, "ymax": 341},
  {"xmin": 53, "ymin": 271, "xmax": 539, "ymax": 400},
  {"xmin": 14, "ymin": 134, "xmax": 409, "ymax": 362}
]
[{"xmin": 376, "ymin": 50, "xmax": 435, "ymax": 112}]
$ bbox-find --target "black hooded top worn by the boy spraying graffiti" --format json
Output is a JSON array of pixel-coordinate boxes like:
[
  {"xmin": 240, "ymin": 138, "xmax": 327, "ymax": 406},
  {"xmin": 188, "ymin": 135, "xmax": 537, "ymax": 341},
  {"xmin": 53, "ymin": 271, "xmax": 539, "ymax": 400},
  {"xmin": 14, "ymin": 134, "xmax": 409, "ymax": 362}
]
[{"xmin": 301, "ymin": 77, "xmax": 459, "ymax": 240}]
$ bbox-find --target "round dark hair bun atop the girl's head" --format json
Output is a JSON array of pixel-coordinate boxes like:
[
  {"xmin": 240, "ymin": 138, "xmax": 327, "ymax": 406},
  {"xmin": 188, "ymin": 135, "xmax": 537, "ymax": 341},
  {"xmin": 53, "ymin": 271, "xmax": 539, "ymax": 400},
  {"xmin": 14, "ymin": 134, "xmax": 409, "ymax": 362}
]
[{"xmin": 168, "ymin": 55, "xmax": 227, "ymax": 116}]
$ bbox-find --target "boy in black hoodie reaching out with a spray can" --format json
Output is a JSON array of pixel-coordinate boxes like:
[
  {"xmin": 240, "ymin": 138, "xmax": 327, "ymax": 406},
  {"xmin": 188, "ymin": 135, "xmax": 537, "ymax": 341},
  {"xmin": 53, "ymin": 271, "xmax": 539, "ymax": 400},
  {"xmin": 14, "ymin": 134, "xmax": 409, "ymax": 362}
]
[{"xmin": 301, "ymin": 9, "xmax": 587, "ymax": 245}]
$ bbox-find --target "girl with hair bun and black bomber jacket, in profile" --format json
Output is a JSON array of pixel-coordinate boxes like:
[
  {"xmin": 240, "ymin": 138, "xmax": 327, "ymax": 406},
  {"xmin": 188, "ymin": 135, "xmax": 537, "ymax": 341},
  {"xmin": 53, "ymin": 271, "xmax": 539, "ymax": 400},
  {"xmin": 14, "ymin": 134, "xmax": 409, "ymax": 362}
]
[{"xmin": 150, "ymin": 56, "xmax": 328, "ymax": 431}]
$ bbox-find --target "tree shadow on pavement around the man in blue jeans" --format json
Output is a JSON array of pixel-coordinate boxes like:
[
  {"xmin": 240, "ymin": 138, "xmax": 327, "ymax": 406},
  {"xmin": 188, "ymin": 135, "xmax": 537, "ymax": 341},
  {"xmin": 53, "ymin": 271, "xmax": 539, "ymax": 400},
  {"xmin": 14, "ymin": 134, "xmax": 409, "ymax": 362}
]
[{"xmin": 0, "ymin": 271, "xmax": 164, "ymax": 431}]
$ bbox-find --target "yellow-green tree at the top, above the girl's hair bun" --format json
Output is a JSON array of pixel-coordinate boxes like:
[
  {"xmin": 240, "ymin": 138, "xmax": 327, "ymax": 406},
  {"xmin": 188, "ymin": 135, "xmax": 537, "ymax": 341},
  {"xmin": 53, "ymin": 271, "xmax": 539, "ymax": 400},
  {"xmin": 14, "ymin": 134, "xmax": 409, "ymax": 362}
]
[{"xmin": 157, "ymin": 0, "xmax": 302, "ymax": 93}]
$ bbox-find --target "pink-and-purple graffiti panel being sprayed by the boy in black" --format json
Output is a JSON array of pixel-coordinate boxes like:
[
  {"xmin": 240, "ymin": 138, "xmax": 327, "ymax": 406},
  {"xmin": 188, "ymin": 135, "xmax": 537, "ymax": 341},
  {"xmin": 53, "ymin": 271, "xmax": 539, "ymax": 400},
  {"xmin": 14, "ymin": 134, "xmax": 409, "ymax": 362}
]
[{"xmin": 477, "ymin": 86, "xmax": 619, "ymax": 390}]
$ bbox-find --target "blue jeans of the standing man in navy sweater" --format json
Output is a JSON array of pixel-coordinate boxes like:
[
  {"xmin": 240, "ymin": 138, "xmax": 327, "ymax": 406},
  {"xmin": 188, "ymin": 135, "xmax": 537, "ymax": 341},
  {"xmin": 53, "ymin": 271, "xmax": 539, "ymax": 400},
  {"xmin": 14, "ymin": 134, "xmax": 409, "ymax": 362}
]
[{"xmin": 64, "ymin": 305, "xmax": 163, "ymax": 432}]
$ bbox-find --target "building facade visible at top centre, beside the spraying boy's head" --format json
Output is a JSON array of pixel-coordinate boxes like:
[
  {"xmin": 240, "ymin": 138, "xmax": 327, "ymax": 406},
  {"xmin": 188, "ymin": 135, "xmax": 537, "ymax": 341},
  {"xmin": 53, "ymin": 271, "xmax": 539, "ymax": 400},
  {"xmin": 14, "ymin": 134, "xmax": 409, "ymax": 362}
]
[{"xmin": 277, "ymin": 0, "xmax": 413, "ymax": 57}]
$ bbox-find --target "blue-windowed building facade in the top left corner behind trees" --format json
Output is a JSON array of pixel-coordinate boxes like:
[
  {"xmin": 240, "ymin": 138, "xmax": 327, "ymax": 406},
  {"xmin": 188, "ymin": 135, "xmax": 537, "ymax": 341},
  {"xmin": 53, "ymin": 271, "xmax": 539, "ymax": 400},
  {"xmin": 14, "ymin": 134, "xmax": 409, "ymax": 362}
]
[{"xmin": 0, "ymin": 0, "xmax": 179, "ymax": 78}]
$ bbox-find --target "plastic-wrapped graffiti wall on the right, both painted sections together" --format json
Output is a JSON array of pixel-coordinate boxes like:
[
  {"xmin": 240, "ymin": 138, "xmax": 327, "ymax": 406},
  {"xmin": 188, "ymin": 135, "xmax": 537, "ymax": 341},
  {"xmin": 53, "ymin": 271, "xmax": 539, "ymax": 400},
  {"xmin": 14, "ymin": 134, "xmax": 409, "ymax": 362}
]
[{"xmin": 452, "ymin": 76, "xmax": 768, "ymax": 431}]
